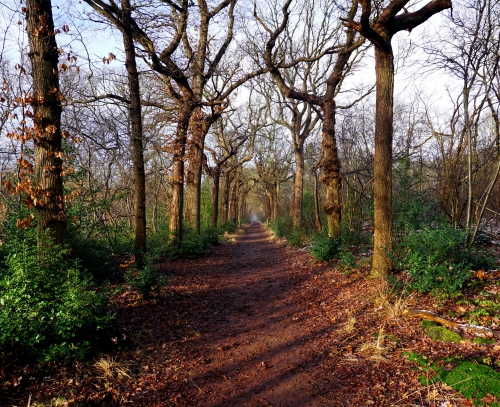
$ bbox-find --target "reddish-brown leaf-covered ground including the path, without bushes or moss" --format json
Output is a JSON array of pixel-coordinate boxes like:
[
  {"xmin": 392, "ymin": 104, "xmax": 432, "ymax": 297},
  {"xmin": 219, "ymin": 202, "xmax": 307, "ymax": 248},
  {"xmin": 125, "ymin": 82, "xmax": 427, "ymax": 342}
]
[{"xmin": 0, "ymin": 224, "xmax": 500, "ymax": 407}]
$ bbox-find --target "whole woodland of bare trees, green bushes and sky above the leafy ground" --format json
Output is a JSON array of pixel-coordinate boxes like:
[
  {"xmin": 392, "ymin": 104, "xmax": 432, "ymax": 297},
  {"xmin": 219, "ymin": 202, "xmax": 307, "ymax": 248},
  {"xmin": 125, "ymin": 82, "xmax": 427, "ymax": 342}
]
[{"xmin": 0, "ymin": 0, "xmax": 500, "ymax": 386}]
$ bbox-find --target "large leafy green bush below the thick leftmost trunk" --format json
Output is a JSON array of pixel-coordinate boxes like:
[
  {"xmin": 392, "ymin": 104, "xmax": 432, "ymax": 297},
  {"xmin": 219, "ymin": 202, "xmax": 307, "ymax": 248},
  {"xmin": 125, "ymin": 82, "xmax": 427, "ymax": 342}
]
[{"xmin": 0, "ymin": 235, "xmax": 114, "ymax": 362}]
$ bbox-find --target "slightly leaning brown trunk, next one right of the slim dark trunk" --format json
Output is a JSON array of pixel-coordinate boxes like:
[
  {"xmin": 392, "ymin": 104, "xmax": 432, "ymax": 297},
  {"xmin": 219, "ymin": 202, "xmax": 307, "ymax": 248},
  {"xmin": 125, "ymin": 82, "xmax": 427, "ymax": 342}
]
[{"xmin": 169, "ymin": 102, "xmax": 194, "ymax": 244}]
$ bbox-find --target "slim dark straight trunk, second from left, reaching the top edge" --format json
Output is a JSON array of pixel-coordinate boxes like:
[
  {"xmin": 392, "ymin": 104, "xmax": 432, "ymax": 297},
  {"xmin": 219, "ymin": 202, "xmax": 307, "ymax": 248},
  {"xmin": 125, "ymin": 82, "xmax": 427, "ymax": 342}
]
[{"xmin": 122, "ymin": 0, "xmax": 146, "ymax": 264}]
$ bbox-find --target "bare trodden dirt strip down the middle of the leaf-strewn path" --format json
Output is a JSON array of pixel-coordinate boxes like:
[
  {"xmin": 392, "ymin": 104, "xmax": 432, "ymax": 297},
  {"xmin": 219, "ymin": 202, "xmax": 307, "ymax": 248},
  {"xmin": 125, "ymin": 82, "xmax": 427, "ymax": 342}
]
[{"xmin": 174, "ymin": 224, "xmax": 330, "ymax": 406}]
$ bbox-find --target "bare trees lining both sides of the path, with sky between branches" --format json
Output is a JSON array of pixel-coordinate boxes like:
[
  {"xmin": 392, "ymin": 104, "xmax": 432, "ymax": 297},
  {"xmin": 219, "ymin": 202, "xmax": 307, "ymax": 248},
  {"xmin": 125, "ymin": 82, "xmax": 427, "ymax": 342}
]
[{"xmin": 1, "ymin": 0, "xmax": 500, "ymax": 277}]
